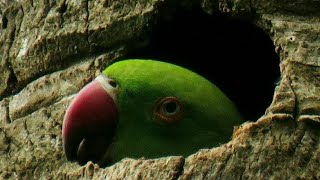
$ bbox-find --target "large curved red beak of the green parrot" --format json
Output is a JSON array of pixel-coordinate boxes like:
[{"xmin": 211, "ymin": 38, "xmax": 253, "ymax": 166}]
[{"xmin": 62, "ymin": 75, "xmax": 118, "ymax": 163}]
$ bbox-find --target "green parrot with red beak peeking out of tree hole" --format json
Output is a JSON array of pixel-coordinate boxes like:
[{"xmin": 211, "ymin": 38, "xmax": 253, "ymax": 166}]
[{"xmin": 62, "ymin": 59, "xmax": 244, "ymax": 164}]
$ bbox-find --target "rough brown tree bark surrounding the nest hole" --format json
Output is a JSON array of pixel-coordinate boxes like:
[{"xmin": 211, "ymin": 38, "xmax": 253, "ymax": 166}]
[{"xmin": 0, "ymin": 0, "xmax": 320, "ymax": 179}]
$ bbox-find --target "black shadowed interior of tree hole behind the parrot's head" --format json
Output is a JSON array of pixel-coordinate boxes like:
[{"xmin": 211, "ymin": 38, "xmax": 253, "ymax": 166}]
[{"xmin": 123, "ymin": 5, "xmax": 280, "ymax": 121}]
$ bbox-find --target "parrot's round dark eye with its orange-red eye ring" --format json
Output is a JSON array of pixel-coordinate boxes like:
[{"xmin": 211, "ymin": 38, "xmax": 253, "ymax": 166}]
[{"xmin": 153, "ymin": 97, "xmax": 183, "ymax": 123}]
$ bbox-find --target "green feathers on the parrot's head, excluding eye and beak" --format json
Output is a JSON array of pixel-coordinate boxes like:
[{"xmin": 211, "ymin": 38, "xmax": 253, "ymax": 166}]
[{"xmin": 103, "ymin": 60, "xmax": 243, "ymax": 161}]
